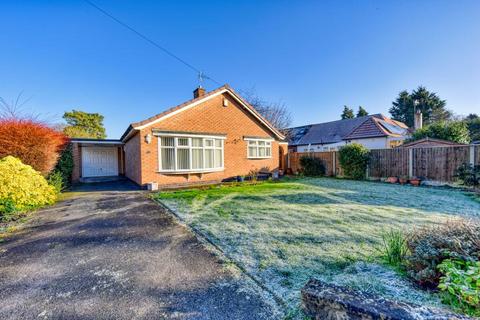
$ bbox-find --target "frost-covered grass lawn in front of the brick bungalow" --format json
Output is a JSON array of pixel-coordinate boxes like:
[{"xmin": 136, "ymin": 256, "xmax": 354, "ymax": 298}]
[{"xmin": 154, "ymin": 178, "xmax": 480, "ymax": 312}]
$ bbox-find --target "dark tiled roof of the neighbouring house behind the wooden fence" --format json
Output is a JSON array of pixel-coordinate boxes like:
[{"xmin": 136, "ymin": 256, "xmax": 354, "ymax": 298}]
[{"xmin": 288, "ymin": 114, "xmax": 408, "ymax": 145}]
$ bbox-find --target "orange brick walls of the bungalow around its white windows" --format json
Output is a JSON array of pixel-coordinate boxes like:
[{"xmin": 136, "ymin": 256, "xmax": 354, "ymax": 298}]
[{"xmin": 135, "ymin": 93, "xmax": 279, "ymax": 185}]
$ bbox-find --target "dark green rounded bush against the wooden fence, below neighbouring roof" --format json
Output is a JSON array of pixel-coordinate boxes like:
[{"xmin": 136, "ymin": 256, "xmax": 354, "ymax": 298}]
[{"xmin": 339, "ymin": 143, "xmax": 369, "ymax": 180}]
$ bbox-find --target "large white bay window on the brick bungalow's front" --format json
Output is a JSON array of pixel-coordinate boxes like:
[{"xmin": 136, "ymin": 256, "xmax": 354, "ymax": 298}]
[{"xmin": 158, "ymin": 135, "xmax": 224, "ymax": 172}]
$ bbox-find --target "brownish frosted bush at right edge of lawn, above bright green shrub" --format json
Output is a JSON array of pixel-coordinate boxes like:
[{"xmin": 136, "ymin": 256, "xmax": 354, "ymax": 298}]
[{"xmin": 405, "ymin": 219, "xmax": 480, "ymax": 288}]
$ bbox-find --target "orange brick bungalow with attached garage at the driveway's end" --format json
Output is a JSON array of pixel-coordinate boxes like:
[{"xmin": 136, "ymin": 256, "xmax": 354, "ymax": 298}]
[{"xmin": 72, "ymin": 85, "xmax": 287, "ymax": 186}]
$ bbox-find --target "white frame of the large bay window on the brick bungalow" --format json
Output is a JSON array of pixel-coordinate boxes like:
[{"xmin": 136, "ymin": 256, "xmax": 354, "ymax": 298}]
[{"xmin": 156, "ymin": 134, "xmax": 225, "ymax": 173}]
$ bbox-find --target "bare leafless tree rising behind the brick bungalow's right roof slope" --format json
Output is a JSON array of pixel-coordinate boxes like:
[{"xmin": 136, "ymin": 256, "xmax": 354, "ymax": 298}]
[{"xmin": 243, "ymin": 89, "xmax": 292, "ymax": 130}]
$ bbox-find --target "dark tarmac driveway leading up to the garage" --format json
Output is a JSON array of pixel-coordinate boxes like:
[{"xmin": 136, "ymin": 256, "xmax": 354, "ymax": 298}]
[{"xmin": 0, "ymin": 185, "xmax": 280, "ymax": 319}]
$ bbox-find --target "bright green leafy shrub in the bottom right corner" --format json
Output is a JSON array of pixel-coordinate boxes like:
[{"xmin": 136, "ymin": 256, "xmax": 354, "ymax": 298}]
[{"xmin": 438, "ymin": 259, "xmax": 480, "ymax": 316}]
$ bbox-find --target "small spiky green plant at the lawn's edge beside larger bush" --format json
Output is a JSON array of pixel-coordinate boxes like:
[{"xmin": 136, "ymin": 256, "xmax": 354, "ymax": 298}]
[{"xmin": 382, "ymin": 229, "xmax": 408, "ymax": 267}]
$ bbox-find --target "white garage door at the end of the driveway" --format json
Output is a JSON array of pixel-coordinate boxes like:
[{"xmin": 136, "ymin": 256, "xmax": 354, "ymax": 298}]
[{"xmin": 82, "ymin": 147, "xmax": 118, "ymax": 178}]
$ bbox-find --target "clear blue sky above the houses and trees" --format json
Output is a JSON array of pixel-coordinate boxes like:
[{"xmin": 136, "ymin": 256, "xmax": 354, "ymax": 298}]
[{"xmin": 0, "ymin": 0, "xmax": 480, "ymax": 138}]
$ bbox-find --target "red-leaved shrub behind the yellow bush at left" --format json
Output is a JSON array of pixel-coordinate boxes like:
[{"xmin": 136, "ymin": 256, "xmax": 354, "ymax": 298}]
[{"xmin": 0, "ymin": 118, "xmax": 68, "ymax": 175}]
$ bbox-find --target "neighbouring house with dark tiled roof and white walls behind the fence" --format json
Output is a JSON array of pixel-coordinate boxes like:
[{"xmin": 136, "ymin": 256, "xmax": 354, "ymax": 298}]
[{"xmin": 287, "ymin": 114, "xmax": 410, "ymax": 152}]
